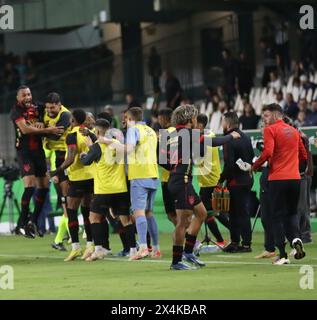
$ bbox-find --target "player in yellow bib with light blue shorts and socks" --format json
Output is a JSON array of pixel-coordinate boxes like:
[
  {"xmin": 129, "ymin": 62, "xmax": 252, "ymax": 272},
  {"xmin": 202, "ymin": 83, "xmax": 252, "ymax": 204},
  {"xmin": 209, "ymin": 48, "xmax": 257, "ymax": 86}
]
[{"xmin": 99, "ymin": 107, "xmax": 161, "ymax": 260}]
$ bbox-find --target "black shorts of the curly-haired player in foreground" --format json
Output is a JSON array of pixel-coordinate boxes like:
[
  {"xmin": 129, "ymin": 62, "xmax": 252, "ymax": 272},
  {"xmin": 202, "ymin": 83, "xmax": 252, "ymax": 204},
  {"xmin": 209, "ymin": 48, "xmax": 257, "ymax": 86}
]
[{"xmin": 168, "ymin": 176, "xmax": 201, "ymax": 210}]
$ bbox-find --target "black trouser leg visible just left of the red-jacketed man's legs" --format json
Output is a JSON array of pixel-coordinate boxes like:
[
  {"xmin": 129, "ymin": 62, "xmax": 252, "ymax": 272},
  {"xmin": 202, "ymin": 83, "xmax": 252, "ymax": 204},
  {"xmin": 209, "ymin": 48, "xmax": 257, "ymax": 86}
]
[{"xmin": 260, "ymin": 191, "xmax": 275, "ymax": 252}]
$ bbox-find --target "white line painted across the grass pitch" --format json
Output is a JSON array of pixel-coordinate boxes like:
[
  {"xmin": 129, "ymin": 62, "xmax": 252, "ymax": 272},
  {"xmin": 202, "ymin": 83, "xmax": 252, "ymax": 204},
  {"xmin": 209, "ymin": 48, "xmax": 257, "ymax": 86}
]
[{"xmin": 0, "ymin": 254, "xmax": 317, "ymax": 268}]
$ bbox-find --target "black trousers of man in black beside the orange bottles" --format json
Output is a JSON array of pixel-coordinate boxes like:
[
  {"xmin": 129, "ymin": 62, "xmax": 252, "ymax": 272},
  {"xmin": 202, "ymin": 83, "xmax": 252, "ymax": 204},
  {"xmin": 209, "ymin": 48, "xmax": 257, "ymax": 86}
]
[{"xmin": 229, "ymin": 186, "xmax": 252, "ymax": 246}]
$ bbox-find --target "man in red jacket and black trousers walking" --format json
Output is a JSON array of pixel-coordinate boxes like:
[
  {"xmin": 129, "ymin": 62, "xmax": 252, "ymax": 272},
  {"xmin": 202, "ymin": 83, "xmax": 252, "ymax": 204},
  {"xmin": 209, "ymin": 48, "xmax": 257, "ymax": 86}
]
[{"xmin": 252, "ymin": 103, "xmax": 307, "ymax": 265}]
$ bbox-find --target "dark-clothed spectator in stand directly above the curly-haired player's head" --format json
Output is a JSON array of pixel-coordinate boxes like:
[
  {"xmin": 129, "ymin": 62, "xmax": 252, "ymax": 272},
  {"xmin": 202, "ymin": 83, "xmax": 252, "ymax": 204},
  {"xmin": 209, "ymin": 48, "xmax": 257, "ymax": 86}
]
[{"xmin": 164, "ymin": 71, "xmax": 182, "ymax": 110}]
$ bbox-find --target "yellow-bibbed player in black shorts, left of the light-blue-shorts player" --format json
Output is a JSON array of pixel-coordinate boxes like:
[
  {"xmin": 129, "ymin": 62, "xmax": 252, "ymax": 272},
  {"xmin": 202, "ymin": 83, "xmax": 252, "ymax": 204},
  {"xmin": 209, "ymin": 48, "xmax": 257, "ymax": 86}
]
[{"xmin": 80, "ymin": 119, "xmax": 136, "ymax": 261}]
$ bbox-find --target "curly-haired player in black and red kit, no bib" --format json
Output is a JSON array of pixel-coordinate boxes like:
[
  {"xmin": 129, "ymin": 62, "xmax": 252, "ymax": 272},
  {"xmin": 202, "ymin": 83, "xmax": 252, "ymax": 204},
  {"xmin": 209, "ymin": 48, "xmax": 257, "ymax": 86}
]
[{"xmin": 160, "ymin": 105, "xmax": 240, "ymax": 270}]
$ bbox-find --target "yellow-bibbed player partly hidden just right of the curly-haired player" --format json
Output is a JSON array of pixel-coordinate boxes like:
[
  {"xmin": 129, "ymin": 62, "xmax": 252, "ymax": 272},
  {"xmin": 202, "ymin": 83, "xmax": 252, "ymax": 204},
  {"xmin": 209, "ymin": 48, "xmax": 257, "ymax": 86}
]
[{"xmin": 197, "ymin": 113, "xmax": 230, "ymax": 246}]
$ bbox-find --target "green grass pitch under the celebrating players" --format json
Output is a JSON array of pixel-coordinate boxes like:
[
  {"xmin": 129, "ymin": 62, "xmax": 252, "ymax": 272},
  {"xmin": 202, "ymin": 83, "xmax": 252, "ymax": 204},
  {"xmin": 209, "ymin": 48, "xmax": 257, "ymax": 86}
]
[{"xmin": 0, "ymin": 232, "xmax": 317, "ymax": 300}]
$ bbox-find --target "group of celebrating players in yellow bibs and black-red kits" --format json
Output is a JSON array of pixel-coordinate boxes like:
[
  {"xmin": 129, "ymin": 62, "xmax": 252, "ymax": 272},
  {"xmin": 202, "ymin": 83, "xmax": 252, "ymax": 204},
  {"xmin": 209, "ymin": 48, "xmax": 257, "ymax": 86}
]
[{"xmin": 11, "ymin": 86, "xmax": 240, "ymax": 270}]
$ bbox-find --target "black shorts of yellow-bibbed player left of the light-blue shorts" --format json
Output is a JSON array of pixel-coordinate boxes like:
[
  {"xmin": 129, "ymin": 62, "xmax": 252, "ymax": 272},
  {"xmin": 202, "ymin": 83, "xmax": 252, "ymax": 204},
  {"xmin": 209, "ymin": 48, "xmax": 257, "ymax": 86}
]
[{"xmin": 90, "ymin": 192, "xmax": 130, "ymax": 216}]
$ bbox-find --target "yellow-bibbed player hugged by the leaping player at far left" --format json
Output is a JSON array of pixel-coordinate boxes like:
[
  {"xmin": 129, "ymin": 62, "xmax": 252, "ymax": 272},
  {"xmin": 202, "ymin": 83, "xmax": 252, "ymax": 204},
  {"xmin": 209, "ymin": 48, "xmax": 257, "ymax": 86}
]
[{"xmin": 44, "ymin": 92, "xmax": 71, "ymax": 251}]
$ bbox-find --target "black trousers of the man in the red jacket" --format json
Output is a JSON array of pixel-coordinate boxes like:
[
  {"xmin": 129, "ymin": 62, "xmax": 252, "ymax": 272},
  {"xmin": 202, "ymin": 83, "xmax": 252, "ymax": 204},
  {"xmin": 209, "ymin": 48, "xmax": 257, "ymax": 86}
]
[{"xmin": 269, "ymin": 180, "xmax": 300, "ymax": 251}]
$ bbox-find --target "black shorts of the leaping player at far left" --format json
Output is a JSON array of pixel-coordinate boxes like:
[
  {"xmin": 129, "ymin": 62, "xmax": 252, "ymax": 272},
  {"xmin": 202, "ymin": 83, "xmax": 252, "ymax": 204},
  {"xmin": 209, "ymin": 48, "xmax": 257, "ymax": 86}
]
[{"xmin": 17, "ymin": 149, "xmax": 47, "ymax": 177}]
